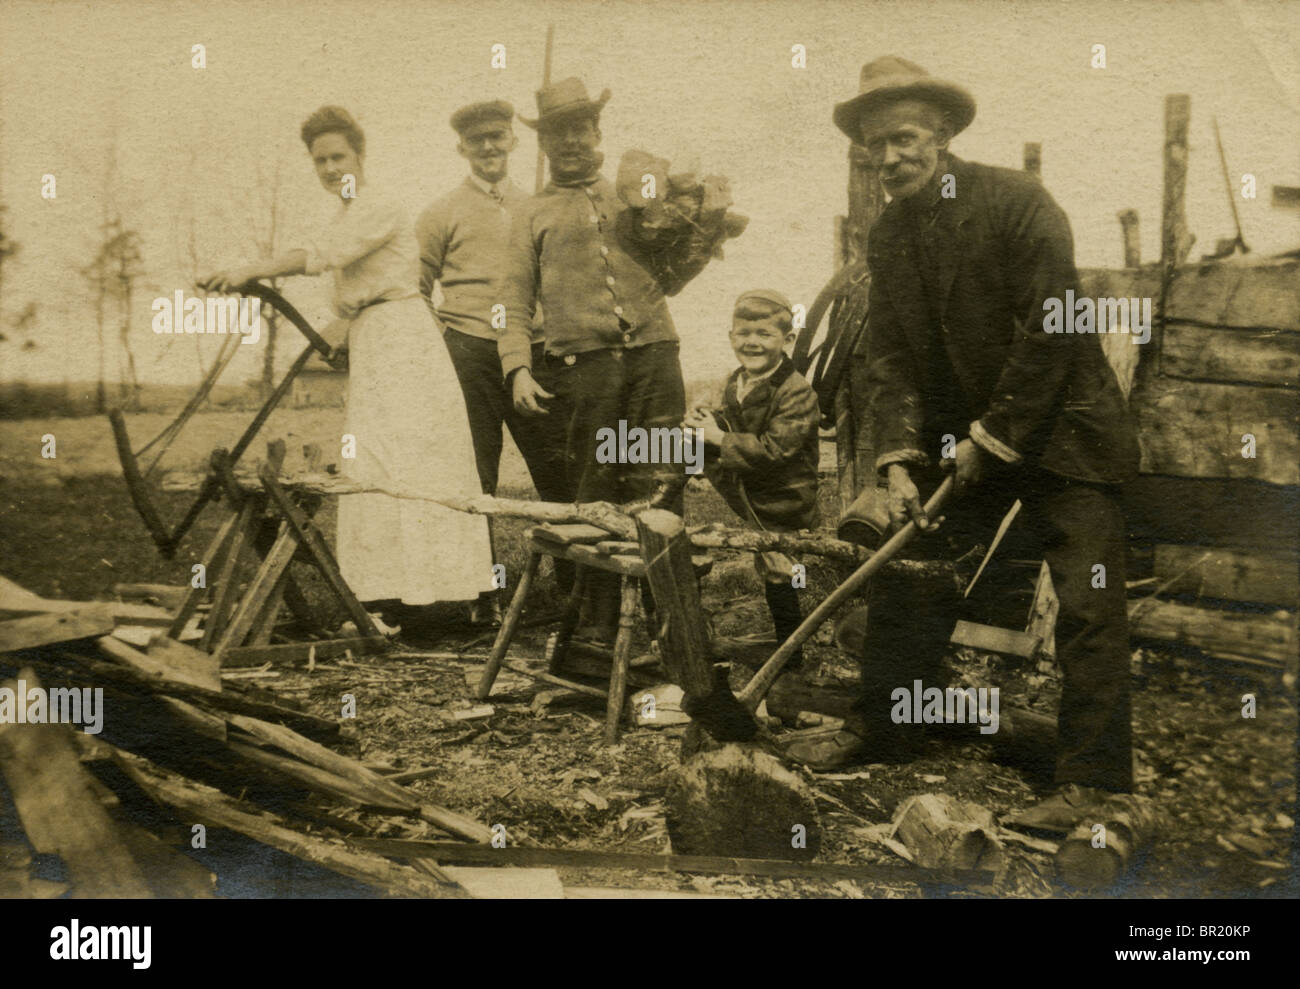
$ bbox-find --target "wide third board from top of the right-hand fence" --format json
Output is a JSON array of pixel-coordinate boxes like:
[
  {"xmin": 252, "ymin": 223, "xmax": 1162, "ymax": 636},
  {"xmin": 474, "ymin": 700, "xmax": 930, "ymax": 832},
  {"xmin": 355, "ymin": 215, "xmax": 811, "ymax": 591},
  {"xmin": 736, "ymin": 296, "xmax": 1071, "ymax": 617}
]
[{"xmin": 1132, "ymin": 374, "xmax": 1300, "ymax": 483}]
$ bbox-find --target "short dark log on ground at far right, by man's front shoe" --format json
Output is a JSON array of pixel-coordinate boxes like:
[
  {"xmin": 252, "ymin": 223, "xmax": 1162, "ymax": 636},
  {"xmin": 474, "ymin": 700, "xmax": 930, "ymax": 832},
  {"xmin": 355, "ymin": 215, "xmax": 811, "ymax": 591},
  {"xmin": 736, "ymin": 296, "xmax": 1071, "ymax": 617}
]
[{"xmin": 1056, "ymin": 794, "xmax": 1166, "ymax": 890}]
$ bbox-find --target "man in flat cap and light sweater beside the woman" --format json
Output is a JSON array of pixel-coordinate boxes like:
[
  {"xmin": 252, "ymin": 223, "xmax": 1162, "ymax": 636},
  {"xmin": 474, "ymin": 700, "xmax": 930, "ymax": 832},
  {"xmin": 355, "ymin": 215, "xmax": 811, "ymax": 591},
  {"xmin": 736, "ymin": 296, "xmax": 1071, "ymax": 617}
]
[{"xmin": 416, "ymin": 100, "xmax": 567, "ymax": 621}]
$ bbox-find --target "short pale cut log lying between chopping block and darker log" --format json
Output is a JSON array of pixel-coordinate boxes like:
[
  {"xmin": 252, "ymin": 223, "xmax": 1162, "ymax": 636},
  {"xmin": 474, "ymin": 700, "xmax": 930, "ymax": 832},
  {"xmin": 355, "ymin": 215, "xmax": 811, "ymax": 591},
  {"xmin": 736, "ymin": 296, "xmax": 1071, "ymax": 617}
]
[{"xmin": 891, "ymin": 793, "xmax": 1005, "ymax": 871}]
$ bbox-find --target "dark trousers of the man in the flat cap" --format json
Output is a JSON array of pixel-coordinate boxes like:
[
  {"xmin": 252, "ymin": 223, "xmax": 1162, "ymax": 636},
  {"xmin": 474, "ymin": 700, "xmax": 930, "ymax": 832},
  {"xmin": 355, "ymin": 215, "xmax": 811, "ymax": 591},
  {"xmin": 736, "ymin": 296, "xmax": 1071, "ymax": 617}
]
[{"xmin": 443, "ymin": 330, "xmax": 572, "ymax": 502}]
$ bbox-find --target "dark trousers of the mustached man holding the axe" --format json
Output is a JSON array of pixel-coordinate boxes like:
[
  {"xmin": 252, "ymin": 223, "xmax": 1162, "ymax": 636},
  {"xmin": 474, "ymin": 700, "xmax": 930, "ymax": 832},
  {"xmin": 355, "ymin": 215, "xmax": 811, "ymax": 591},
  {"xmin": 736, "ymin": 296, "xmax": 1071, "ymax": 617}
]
[{"xmin": 853, "ymin": 467, "xmax": 1132, "ymax": 791}]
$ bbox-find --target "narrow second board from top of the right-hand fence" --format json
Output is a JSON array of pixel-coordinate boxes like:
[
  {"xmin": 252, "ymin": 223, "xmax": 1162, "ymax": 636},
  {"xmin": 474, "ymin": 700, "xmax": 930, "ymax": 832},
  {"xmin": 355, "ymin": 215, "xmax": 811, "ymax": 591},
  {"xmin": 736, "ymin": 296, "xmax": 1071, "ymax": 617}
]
[{"xmin": 1160, "ymin": 321, "xmax": 1300, "ymax": 389}]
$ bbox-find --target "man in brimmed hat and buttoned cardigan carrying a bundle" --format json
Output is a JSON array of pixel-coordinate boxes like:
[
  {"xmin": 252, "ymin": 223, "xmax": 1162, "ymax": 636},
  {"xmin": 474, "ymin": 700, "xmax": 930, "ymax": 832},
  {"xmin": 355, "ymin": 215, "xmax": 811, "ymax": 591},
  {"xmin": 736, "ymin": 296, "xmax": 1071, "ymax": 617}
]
[{"xmin": 499, "ymin": 78, "xmax": 710, "ymax": 642}]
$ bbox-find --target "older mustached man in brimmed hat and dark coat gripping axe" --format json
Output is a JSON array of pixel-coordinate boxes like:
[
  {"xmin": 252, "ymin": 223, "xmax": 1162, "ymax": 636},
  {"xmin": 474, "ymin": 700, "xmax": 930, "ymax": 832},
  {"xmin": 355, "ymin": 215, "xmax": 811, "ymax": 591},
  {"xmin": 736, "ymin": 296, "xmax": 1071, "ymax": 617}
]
[{"xmin": 790, "ymin": 57, "xmax": 1138, "ymax": 829}]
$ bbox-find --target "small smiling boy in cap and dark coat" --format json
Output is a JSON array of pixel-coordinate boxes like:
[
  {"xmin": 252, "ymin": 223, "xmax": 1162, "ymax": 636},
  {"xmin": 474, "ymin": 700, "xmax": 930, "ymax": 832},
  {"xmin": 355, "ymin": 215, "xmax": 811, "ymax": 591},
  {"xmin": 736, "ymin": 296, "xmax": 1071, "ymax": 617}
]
[{"xmin": 685, "ymin": 289, "xmax": 822, "ymax": 669}]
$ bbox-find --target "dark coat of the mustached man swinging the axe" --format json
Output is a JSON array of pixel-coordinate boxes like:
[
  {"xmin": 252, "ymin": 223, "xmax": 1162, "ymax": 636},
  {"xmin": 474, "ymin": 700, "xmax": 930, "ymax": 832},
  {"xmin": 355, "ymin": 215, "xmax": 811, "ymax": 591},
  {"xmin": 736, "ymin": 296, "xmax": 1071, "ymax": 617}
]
[{"xmin": 867, "ymin": 156, "xmax": 1139, "ymax": 483}]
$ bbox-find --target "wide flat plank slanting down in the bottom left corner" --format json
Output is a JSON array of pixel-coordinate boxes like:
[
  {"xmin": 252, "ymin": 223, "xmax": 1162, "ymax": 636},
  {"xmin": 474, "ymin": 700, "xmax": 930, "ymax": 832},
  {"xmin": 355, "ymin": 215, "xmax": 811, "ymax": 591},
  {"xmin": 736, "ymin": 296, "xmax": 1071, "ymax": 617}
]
[{"xmin": 0, "ymin": 668, "xmax": 151, "ymax": 898}]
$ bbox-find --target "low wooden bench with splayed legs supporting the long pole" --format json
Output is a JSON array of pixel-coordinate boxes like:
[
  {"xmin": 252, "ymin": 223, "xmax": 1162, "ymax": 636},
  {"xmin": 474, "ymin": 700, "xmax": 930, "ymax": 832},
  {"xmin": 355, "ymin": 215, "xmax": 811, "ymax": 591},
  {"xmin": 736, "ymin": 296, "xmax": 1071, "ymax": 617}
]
[{"xmin": 476, "ymin": 525, "xmax": 712, "ymax": 745}]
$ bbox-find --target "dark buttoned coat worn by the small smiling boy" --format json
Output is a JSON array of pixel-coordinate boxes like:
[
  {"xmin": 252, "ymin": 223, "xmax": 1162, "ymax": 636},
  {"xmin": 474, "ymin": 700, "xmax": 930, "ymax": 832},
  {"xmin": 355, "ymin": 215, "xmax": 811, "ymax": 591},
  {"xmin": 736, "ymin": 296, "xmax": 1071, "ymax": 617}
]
[{"xmin": 705, "ymin": 356, "xmax": 822, "ymax": 532}]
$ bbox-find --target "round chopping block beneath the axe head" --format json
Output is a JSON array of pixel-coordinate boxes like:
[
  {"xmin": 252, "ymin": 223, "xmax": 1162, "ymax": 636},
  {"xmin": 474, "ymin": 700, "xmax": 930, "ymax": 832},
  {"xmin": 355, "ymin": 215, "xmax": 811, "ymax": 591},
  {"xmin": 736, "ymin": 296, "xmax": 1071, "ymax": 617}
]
[{"xmin": 666, "ymin": 743, "xmax": 822, "ymax": 862}]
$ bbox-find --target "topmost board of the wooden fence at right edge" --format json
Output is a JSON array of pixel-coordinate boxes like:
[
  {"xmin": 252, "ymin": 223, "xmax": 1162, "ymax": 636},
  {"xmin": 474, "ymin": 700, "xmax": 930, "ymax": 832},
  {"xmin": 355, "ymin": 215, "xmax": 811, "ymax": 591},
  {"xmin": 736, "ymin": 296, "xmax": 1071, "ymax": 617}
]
[{"xmin": 1165, "ymin": 257, "xmax": 1300, "ymax": 330}]
